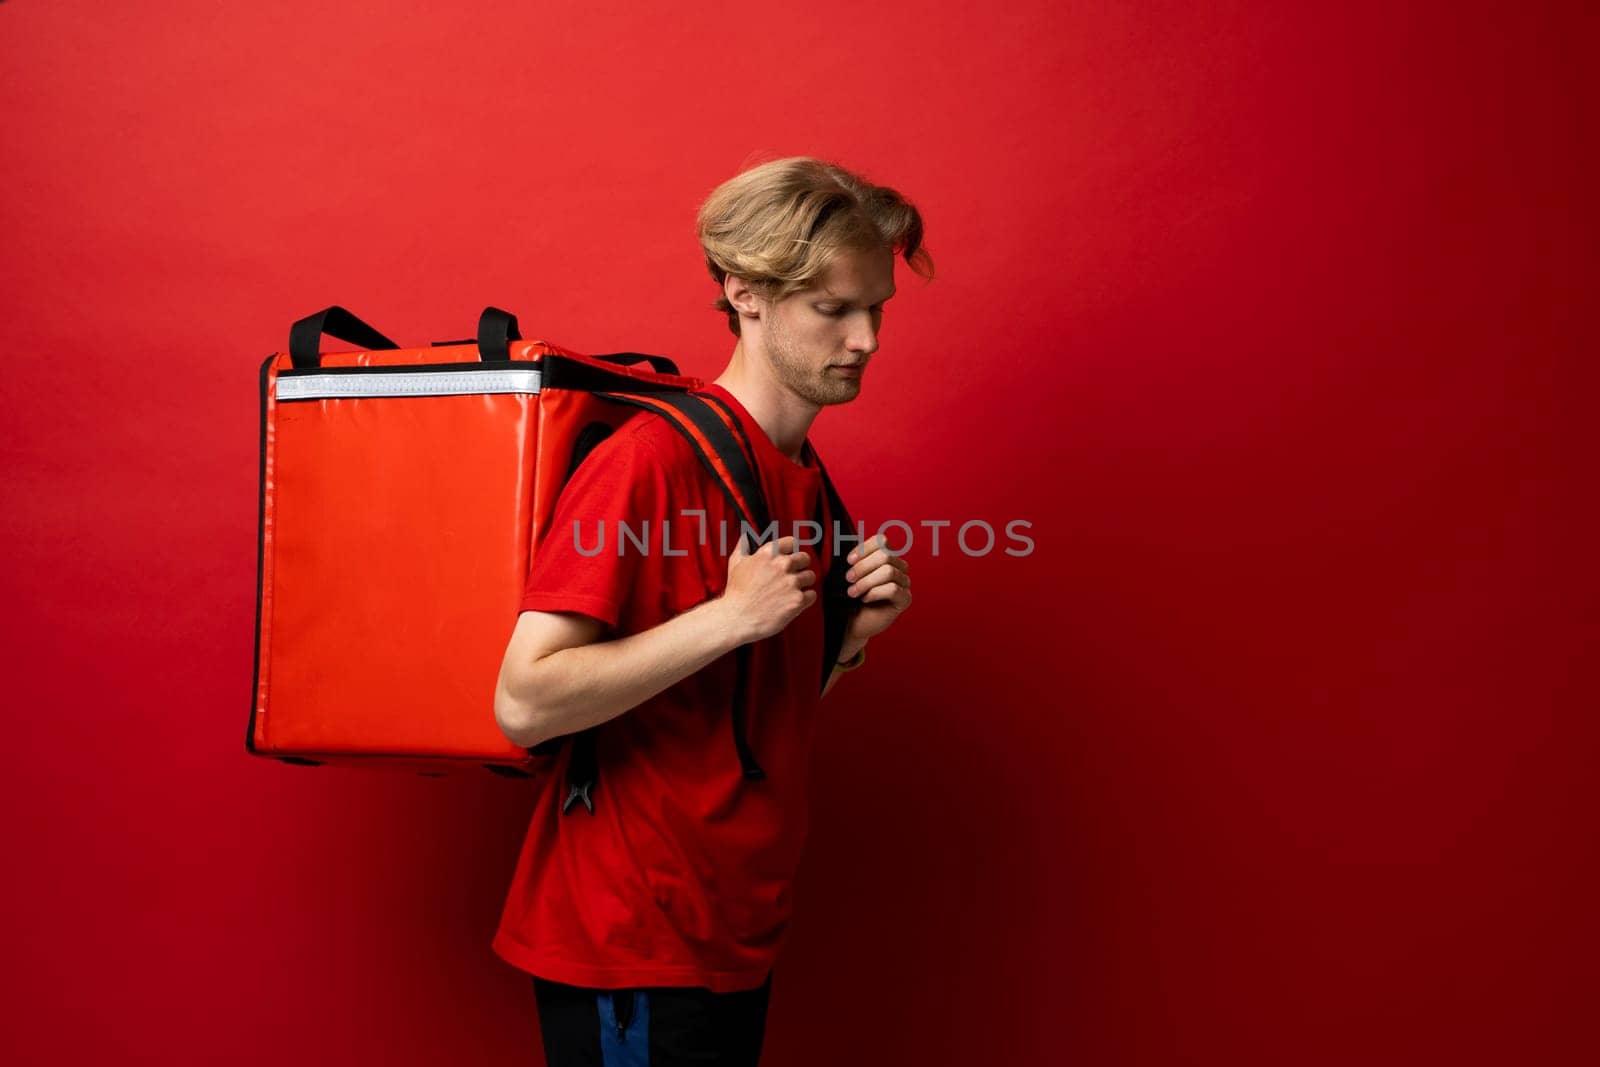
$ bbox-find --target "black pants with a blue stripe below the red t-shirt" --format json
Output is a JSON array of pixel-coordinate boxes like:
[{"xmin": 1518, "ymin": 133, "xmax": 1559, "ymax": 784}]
[{"xmin": 533, "ymin": 974, "xmax": 773, "ymax": 1067}]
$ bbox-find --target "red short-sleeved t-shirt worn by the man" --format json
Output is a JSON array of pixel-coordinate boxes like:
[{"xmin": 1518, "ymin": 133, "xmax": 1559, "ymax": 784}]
[{"xmin": 494, "ymin": 386, "xmax": 832, "ymax": 992}]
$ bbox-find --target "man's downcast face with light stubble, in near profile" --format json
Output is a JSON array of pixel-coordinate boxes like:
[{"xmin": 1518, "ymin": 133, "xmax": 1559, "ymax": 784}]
[{"xmin": 760, "ymin": 248, "xmax": 894, "ymax": 406}]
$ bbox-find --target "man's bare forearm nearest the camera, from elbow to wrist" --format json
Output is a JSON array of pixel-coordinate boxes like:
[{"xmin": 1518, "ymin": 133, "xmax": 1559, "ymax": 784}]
[{"xmin": 510, "ymin": 598, "xmax": 744, "ymax": 747}]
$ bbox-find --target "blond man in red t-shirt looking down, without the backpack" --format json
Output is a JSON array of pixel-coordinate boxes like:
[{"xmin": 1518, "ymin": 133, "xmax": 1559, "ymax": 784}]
[{"xmin": 494, "ymin": 157, "xmax": 931, "ymax": 1067}]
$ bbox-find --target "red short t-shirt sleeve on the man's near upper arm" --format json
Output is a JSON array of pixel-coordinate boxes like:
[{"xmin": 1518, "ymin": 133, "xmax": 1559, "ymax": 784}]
[{"xmin": 522, "ymin": 430, "xmax": 669, "ymax": 629}]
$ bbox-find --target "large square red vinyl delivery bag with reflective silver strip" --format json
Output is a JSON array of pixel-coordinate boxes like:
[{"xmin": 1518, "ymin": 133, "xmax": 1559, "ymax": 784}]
[{"xmin": 246, "ymin": 309, "xmax": 699, "ymax": 774}]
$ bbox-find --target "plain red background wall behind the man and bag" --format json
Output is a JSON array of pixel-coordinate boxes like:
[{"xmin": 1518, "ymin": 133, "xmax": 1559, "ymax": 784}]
[{"xmin": 0, "ymin": 0, "xmax": 1600, "ymax": 1065}]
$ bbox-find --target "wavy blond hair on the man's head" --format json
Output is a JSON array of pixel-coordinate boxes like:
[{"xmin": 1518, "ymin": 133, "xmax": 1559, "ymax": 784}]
[{"xmin": 696, "ymin": 155, "xmax": 933, "ymax": 338}]
